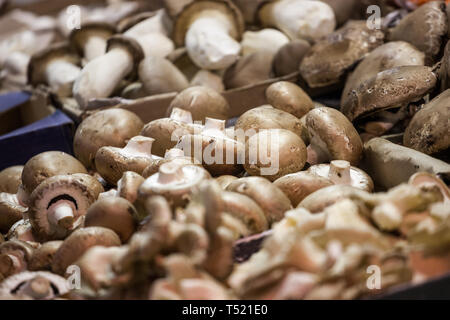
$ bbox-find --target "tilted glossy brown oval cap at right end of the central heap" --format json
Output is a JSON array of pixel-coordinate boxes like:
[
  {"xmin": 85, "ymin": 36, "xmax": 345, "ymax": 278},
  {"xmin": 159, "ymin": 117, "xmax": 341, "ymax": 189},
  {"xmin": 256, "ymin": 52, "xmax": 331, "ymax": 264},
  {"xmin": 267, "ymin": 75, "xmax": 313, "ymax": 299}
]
[{"xmin": 306, "ymin": 107, "xmax": 363, "ymax": 166}]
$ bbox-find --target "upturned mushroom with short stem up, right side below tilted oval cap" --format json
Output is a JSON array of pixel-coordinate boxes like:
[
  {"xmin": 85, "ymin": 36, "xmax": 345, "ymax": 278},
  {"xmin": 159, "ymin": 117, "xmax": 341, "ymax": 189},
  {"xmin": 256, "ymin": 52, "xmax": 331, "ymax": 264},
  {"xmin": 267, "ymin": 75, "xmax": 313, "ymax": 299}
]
[{"xmin": 307, "ymin": 160, "xmax": 373, "ymax": 192}]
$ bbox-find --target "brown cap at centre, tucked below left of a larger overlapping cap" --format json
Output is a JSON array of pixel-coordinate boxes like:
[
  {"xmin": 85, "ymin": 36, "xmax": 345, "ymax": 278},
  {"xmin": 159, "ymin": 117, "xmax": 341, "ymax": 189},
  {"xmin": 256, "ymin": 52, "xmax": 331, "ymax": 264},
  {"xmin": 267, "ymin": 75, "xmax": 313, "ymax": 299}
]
[{"xmin": 222, "ymin": 191, "xmax": 269, "ymax": 234}]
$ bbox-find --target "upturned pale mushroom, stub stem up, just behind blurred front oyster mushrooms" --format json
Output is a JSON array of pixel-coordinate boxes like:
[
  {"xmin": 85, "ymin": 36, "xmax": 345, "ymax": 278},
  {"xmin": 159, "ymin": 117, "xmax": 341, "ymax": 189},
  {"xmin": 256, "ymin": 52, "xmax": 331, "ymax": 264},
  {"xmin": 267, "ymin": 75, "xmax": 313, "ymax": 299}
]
[{"xmin": 139, "ymin": 162, "xmax": 210, "ymax": 207}]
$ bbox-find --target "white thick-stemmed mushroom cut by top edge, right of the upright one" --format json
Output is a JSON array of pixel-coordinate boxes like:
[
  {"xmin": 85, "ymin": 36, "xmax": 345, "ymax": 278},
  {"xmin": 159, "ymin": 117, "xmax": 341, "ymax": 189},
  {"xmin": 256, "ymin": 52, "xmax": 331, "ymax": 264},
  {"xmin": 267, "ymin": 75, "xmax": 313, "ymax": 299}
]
[{"xmin": 258, "ymin": 0, "xmax": 336, "ymax": 40}]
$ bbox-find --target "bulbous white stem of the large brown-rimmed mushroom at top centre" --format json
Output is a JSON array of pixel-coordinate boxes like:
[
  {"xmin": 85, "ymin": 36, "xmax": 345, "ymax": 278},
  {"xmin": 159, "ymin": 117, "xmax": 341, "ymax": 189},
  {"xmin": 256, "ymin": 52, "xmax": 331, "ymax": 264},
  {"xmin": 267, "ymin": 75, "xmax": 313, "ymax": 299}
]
[{"xmin": 185, "ymin": 10, "xmax": 241, "ymax": 70}]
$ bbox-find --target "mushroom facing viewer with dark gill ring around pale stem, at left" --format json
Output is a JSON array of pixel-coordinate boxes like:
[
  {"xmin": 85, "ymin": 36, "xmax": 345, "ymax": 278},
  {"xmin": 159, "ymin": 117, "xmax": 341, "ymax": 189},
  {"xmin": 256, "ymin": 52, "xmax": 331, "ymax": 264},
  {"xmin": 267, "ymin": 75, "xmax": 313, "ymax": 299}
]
[{"xmin": 28, "ymin": 173, "xmax": 103, "ymax": 240}]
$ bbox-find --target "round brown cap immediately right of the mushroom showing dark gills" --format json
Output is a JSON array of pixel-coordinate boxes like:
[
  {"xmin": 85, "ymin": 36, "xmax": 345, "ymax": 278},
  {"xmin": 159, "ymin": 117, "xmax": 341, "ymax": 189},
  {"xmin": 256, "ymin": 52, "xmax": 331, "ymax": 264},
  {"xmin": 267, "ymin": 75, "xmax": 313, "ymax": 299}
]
[{"xmin": 84, "ymin": 197, "xmax": 136, "ymax": 243}]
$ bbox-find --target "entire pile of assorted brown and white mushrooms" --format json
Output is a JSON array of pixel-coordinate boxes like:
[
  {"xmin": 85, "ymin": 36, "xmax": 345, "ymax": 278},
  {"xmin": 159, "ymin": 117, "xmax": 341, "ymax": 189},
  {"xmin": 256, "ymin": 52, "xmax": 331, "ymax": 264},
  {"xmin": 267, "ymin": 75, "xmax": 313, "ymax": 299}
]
[{"xmin": 0, "ymin": 0, "xmax": 450, "ymax": 300}]
